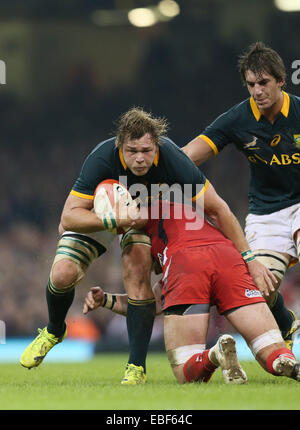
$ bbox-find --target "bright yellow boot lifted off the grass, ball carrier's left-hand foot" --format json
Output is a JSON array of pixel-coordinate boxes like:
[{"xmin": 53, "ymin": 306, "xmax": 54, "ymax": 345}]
[{"xmin": 20, "ymin": 327, "xmax": 67, "ymax": 369}]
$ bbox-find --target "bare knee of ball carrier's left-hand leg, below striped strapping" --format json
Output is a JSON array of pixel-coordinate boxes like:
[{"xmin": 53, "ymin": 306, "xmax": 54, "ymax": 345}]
[{"xmin": 51, "ymin": 259, "xmax": 79, "ymax": 290}]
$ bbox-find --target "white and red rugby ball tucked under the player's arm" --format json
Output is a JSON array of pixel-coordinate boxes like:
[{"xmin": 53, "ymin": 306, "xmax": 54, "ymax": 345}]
[{"xmin": 94, "ymin": 179, "xmax": 132, "ymax": 234}]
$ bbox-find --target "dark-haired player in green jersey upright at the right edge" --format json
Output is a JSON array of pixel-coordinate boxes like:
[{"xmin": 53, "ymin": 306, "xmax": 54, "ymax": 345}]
[{"xmin": 183, "ymin": 42, "xmax": 300, "ymax": 349}]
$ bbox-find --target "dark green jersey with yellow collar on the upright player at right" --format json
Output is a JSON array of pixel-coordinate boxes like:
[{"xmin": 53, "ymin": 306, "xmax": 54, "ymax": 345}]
[{"xmin": 199, "ymin": 92, "xmax": 300, "ymax": 215}]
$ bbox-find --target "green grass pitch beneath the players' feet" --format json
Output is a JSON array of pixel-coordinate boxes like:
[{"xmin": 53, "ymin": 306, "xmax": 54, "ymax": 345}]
[{"xmin": 0, "ymin": 353, "xmax": 300, "ymax": 410}]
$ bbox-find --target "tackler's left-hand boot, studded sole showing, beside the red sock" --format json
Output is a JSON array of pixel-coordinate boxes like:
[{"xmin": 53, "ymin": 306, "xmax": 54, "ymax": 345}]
[{"xmin": 208, "ymin": 334, "xmax": 247, "ymax": 384}]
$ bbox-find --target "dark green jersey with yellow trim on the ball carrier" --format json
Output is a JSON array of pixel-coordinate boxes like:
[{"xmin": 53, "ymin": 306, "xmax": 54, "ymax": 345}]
[{"xmin": 71, "ymin": 137, "xmax": 209, "ymax": 205}]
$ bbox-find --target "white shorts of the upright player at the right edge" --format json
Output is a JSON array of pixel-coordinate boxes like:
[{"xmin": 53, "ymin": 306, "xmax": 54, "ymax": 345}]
[{"xmin": 245, "ymin": 203, "xmax": 300, "ymax": 260}]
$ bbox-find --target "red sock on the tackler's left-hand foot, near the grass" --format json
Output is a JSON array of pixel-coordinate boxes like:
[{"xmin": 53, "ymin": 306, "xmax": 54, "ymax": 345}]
[{"xmin": 183, "ymin": 349, "xmax": 218, "ymax": 382}]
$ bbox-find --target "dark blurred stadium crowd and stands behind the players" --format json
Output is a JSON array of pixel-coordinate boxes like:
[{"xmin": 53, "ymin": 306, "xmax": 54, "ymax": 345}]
[{"xmin": 0, "ymin": 0, "xmax": 300, "ymax": 360}]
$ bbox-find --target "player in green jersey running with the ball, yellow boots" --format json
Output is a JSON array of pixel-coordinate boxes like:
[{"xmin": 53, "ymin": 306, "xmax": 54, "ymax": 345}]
[{"xmin": 20, "ymin": 108, "xmax": 273, "ymax": 385}]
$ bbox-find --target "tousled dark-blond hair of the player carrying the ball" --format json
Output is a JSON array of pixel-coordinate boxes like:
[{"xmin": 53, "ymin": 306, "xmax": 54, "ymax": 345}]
[{"xmin": 116, "ymin": 107, "xmax": 168, "ymax": 147}]
